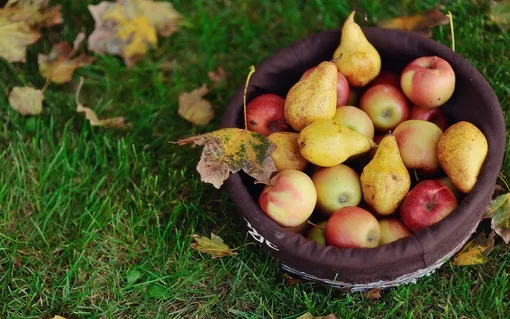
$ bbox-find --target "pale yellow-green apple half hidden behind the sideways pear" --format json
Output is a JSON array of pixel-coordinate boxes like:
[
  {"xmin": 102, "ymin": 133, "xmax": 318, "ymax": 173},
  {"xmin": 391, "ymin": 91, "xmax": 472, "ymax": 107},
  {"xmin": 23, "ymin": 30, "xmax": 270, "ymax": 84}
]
[{"xmin": 333, "ymin": 106, "xmax": 374, "ymax": 139}]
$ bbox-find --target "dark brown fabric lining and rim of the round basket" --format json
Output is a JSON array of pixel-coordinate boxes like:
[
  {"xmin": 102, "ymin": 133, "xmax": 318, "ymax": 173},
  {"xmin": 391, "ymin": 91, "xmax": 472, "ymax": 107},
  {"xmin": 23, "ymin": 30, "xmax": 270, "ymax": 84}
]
[{"xmin": 222, "ymin": 27, "xmax": 505, "ymax": 284}]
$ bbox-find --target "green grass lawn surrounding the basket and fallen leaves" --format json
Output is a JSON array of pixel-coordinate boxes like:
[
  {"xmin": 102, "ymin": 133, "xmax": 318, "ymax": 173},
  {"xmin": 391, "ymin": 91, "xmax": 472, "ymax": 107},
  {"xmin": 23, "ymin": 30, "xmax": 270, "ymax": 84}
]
[{"xmin": 0, "ymin": 0, "xmax": 510, "ymax": 318}]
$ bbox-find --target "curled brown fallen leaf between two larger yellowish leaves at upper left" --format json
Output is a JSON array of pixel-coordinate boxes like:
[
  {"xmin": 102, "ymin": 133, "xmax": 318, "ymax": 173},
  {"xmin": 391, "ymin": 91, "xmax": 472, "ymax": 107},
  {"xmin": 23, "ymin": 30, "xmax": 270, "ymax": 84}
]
[{"xmin": 38, "ymin": 33, "xmax": 94, "ymax": 84}]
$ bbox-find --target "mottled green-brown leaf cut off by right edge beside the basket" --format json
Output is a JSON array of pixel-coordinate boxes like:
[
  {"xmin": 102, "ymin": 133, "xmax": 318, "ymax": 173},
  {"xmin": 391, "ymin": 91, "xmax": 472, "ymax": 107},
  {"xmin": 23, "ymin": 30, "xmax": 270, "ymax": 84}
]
[{"xmin": 484, "ymin": 193, "xmax": 510, "ymax": 244}]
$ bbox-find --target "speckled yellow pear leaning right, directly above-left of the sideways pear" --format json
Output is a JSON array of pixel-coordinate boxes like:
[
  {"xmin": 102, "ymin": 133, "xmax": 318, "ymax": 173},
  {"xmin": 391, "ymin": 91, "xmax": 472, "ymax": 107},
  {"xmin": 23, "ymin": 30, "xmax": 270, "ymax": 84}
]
[{"xmin": 284, "ymin": 61, "xmax": 338, "ymax": 132}]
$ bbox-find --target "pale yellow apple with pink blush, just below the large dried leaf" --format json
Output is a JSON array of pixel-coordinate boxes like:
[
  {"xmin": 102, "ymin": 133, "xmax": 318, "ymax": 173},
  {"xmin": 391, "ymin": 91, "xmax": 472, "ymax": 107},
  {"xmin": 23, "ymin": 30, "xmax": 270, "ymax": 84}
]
[{"xmin": 259, "ymin": 169, "xmax": 317, "ymax": 227}]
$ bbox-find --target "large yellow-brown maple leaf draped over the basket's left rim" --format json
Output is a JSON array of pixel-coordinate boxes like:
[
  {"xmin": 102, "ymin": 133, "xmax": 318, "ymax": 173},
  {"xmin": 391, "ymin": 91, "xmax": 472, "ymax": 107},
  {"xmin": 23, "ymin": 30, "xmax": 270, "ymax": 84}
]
[{"xmin": 176, "ymin": 128, "xmax": 276, "ymax": 188}]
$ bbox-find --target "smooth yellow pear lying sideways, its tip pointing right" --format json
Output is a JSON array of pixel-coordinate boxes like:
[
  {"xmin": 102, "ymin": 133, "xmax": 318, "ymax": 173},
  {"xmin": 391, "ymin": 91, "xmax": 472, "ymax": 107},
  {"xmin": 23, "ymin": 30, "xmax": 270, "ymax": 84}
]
[{"xmin": 298, "ymin": 119, "xmax": 376, "ymax": 167}]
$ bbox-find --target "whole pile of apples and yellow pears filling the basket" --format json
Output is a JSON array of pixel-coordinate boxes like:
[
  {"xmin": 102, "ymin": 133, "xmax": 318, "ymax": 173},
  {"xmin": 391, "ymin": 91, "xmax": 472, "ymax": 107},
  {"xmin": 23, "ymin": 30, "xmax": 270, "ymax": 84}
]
[{"xmin": 246, "ymin": 12, "xmax": 488, "ymax": 248}]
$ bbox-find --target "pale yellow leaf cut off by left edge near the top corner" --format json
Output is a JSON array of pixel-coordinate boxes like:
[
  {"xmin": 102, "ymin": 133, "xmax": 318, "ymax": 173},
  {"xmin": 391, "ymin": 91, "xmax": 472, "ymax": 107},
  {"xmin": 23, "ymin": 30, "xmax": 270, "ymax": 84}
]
[{"xmin": 0, "ymin": 17, "xmax": 41, "ymax": 62}]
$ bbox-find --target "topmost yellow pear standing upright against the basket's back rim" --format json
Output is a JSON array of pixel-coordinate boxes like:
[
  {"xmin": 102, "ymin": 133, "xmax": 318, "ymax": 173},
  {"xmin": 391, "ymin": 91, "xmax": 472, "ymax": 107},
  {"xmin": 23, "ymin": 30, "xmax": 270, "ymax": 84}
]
[{"xmin": 333, "ymin": 11, "xmax": 381, "ymax": 87}]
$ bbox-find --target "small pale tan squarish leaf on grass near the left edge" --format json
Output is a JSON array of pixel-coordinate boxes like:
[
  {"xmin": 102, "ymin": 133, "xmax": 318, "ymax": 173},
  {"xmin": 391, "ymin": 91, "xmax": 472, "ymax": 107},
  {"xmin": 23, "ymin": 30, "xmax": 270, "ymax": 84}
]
[{"xmin": 9, "ymin": 86, "xmax": 44, "ymax": 115}]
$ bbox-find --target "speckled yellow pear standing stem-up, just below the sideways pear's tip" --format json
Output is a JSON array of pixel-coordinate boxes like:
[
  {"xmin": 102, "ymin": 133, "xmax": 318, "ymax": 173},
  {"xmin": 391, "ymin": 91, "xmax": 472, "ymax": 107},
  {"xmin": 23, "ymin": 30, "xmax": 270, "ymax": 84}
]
[{"xmin": 360, "ymin": 134, "xmax": 411, "ymax": 215}]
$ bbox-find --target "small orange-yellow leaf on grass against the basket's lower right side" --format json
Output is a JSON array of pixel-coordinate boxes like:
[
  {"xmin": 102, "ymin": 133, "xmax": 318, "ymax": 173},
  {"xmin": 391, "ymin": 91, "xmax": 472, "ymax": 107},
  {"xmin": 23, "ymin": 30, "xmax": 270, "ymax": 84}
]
[{"xmin": 452, "ymin": 232, "xmax": 495, "ymax": 266}]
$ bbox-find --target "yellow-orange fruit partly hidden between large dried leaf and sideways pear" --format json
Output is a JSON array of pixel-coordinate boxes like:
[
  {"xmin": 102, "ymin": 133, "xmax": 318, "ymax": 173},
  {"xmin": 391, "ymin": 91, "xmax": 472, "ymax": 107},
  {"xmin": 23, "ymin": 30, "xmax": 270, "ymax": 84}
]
[{"xmin": 267, "ymin": 132, "xmax": 308, "ymax": 172}]
